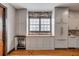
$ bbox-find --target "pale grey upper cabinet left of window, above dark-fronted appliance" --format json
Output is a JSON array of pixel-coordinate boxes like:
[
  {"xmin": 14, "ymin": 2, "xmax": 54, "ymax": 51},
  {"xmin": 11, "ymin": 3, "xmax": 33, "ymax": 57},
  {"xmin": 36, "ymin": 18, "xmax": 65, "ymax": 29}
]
[{"xmin": 15, "ymin": 9, "xmax": 27, "ymax": 35}]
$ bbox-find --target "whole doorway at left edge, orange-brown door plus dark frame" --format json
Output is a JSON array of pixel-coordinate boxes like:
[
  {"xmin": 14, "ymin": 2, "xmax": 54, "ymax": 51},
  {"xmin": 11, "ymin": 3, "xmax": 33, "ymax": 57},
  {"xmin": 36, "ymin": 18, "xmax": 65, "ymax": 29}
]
[{"xmin": 0, "ymin": 4, "xmax": 7, "ymax": 56}]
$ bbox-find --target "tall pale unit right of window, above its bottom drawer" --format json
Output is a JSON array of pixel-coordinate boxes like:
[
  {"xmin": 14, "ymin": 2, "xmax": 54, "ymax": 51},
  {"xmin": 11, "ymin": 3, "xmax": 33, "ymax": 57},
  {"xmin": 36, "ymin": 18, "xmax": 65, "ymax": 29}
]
[{"xmin": 55, "ymin": 7, "xmax": 69, "ymax": 39}]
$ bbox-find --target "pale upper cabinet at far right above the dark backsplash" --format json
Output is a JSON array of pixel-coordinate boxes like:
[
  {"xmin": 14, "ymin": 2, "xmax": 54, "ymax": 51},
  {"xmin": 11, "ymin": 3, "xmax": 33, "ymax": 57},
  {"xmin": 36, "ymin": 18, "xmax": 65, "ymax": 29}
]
[{"xmin": 69, "ymin": 10, "xmax": 79, "ymax": 30}]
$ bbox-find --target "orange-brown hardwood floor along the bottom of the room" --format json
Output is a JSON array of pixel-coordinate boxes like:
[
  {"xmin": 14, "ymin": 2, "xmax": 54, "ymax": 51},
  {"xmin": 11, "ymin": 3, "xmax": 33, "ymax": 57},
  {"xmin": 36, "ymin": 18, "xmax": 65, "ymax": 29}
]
[{"xmin": 9, "ymin": 49, "xmax": 79, "ymax": 56}]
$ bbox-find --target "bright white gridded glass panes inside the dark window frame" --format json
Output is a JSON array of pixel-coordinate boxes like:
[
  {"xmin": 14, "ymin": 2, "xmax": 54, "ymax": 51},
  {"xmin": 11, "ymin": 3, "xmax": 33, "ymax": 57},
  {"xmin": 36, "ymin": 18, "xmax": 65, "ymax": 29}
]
[{"xmin": 30, "ymin": 18, "xmax": 50, "ymax": 32}]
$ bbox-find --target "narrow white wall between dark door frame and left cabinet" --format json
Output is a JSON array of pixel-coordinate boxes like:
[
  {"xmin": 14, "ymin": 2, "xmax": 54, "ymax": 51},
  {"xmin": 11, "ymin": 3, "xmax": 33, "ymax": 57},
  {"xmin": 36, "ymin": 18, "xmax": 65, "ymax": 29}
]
[{"xmin": 3, "ymin": 3, "xmax": 15, "ymax": 52}]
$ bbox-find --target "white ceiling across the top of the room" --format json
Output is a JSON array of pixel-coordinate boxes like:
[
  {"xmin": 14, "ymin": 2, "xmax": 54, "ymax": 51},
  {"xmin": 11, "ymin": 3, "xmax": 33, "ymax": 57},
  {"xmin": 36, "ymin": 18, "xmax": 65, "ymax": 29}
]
[{"xmin": 11, "ymin": 3, "xmax": 79, "ymax": 11}]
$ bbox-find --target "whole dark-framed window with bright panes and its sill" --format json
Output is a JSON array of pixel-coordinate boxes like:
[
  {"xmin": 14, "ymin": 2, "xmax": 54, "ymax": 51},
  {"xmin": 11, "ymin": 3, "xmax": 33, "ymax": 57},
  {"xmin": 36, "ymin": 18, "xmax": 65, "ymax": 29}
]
[{"xmin": 29, "ymin": 11, "xmax": 51, "ymax": 35}]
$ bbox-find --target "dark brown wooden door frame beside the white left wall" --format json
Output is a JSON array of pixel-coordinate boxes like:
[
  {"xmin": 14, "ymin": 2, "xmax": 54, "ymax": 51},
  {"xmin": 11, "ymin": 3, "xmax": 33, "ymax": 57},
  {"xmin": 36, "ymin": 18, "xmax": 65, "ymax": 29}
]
[{"xmin": 0, "ymin": 3, "xmax": 7, "ymax": 56}]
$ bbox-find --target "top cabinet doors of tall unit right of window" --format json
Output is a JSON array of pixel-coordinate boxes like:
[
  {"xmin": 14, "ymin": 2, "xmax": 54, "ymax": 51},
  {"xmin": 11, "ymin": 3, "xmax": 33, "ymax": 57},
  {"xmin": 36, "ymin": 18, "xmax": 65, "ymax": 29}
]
[{"xmin": 55, "ymin": 7, "xmax": 69, "ymax": 24}]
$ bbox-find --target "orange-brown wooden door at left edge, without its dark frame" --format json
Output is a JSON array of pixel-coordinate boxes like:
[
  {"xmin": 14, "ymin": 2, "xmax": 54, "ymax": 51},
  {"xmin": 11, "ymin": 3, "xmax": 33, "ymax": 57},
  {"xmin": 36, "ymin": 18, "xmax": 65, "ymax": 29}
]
[{"xmin": 0, "ymin": 7, "xmax": 3, "ymax": 55}]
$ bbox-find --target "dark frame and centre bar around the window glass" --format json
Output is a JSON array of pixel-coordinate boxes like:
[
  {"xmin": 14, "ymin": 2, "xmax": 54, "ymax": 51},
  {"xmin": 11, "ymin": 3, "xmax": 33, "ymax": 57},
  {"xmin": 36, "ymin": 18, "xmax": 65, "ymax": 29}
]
[{"xmin": 28, "ymin": 12, "xmax": 52, "ymax": 34}]
